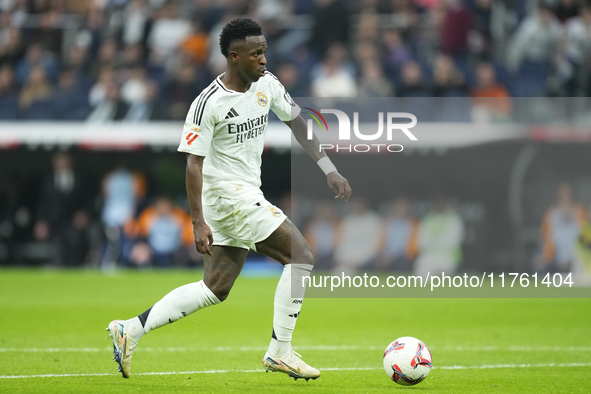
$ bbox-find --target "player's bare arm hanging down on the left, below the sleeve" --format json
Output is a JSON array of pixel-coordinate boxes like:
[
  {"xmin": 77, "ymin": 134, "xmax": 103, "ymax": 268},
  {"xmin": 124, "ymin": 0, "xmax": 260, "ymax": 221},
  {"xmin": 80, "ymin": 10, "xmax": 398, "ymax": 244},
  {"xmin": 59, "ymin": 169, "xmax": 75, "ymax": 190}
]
[{"xmin": 185, "ymin": 154, "xmax": 213, "ymax": 256}]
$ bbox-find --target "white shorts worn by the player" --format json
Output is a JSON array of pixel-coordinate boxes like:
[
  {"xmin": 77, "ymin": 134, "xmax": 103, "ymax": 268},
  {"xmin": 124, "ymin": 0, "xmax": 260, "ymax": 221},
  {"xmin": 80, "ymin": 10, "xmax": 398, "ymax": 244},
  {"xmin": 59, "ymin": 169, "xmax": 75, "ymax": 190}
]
[{"xmin": 203, "ymin": 194, "xmax": 287, "ymax": 251}]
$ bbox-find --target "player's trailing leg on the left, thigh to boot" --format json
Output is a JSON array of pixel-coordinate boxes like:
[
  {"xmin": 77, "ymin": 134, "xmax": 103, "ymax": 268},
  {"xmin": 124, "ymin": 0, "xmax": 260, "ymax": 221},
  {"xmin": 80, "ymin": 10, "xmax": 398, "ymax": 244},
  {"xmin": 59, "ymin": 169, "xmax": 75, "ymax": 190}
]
[{"xmin": 107, "ymin": 246, "xmax": 248, "ymax": 378}]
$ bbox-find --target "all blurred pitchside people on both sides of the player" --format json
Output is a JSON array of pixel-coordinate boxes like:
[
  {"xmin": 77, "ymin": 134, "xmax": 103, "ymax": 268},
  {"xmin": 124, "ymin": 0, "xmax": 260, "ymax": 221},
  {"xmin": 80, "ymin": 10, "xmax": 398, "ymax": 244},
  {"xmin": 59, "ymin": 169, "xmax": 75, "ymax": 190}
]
[{"xmin": 0, "ymin": 152, "xmax": 591, "ymax": 279}]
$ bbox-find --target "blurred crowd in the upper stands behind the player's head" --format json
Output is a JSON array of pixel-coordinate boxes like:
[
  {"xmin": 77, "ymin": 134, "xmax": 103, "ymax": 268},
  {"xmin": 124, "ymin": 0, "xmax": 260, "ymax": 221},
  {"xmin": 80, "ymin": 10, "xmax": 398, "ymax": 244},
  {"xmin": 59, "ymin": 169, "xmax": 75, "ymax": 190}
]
[{"xmin": 0, "ymin": 0, "xmax": 591, "ymax": 122}]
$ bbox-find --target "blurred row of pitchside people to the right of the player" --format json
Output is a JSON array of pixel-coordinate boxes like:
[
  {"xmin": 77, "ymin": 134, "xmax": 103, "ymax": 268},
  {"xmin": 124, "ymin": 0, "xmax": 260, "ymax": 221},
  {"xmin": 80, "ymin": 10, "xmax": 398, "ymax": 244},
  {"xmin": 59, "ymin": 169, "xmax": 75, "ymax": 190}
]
[{"xmin": 300, "ymin": 181, "xmax": 591, "ymax": 281}]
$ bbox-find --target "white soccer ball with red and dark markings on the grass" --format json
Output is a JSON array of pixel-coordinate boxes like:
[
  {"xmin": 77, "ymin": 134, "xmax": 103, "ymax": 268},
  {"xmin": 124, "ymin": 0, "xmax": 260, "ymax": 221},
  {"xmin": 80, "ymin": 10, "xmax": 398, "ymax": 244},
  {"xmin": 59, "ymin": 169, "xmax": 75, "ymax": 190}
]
[{"xmin": 384, "ymin": 337, "xmax": 432, "ymax": 386}]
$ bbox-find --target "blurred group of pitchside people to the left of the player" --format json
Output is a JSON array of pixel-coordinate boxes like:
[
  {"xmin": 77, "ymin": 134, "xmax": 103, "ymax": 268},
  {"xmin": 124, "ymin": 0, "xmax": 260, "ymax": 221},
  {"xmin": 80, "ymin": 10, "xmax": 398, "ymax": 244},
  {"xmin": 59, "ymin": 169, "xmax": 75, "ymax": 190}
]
[{"xmin": 0, "ymin": 152, "xmax": 202, "ymax": 270}]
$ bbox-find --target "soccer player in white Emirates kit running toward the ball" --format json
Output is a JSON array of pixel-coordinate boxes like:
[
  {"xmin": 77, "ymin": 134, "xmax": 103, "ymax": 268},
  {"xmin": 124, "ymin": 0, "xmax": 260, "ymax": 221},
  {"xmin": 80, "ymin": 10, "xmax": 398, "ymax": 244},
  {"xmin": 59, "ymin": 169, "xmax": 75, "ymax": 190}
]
[{"xmin": 107, "ymin": 18, "xmax": 351, "ymax": 380}]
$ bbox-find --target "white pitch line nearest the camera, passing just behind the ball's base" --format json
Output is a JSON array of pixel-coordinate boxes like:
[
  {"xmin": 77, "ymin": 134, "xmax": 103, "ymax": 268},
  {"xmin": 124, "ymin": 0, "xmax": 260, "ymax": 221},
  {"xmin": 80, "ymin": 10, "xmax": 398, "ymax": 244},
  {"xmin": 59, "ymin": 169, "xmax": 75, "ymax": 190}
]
[{"xmin": 0, "ymin": 363, "xmax": 591, "ymax": 379}]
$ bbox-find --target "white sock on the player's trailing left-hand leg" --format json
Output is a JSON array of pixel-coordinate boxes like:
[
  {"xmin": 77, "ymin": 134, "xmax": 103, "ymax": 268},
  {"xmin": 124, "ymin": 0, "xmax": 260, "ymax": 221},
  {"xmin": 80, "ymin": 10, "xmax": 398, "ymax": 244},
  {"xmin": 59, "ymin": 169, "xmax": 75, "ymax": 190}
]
[{"xmin": 127, "ymin": 280, "xmax": 221, "ymax": 341}]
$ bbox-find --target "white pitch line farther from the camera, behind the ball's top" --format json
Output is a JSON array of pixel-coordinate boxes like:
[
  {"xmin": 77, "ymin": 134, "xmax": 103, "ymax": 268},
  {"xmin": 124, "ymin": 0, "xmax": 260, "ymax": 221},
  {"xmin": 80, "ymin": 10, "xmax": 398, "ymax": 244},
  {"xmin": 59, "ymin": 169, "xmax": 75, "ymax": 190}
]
[{"xmin": 0, "ymin": 345, "xmax": 591, "ymax": 353}]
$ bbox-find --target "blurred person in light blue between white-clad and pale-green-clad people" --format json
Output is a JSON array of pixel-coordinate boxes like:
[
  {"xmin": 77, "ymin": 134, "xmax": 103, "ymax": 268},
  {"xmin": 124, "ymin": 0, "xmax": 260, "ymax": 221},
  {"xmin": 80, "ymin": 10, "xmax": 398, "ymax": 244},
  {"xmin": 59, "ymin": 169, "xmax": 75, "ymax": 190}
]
[{"xmin": 376, "ymin": 197, "xmax": 419, "ymax": 272}]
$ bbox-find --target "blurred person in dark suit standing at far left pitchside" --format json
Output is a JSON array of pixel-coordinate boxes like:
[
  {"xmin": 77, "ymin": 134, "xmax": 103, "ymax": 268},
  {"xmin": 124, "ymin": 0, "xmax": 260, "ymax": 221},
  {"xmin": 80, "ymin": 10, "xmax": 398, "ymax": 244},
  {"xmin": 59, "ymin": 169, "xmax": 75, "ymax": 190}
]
[{"xmin": 34, "ymin": 153, "xmax": 90, "ymax": 266}]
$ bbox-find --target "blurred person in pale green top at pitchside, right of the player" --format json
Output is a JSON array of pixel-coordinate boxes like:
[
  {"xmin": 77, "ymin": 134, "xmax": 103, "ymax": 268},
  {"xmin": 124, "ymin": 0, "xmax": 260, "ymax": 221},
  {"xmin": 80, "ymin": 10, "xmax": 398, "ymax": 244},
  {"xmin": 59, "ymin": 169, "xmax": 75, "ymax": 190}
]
[{"xmin": 414, "ymin": 193, "xmax": 464, "ymax": 276}]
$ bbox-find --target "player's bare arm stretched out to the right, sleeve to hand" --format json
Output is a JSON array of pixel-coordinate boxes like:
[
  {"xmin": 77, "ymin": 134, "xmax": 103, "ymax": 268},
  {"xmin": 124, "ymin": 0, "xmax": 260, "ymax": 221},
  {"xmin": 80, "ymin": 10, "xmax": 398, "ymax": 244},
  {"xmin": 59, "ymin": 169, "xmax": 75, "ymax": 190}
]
[{"xmin": 283, "ymin": 115, "xmax": 352, "ymax": 201}]
